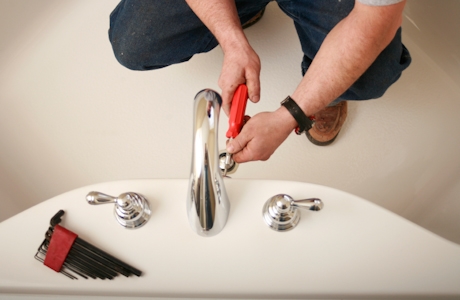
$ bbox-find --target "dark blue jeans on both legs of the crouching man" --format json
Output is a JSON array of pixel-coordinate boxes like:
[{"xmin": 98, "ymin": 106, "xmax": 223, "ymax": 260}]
[{"xmin": 109, "ymin": 0, "xmax": 411, "ymax": 104}]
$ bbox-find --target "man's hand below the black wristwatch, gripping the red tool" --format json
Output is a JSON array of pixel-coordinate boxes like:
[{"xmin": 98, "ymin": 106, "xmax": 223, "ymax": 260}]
[{"xmin": 227, "ymin": 107, "xmax": 297, "ymax": 163}]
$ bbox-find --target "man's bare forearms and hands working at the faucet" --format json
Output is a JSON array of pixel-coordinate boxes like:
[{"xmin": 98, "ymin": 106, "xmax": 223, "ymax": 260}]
[{"xmin": 186, "ymin": 0, "xmax": 405, "ymax": 162}]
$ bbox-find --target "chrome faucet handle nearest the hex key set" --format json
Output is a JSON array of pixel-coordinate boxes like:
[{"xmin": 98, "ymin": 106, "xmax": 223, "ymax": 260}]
[{"xmin": 86, "ymin": 191, "xmax": 151, "ymax": 229}]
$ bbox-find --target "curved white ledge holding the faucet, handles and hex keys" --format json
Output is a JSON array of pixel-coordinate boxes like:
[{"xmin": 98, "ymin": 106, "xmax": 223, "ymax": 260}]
[{"xmin": 0, "ymin": 179, "xmax": 460, "ymax": 299}]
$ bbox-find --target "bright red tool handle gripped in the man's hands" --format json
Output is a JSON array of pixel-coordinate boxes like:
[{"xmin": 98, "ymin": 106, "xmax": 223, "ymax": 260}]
[{"xmin": 226, "ymin": 84, "xmax": 248, "ymax": 138}]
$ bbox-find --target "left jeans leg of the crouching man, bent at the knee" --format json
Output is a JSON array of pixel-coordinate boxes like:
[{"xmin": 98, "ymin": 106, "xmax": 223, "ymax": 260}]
[{"xmin": 109, "ymin": 0, "xmax": 269, "ymax": 70}]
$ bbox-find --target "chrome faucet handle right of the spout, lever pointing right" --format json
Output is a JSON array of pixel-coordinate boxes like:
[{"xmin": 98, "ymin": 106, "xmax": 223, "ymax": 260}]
[{"xmin": 262, "ymin": 194, "xmax": 324, "ymax": 231}]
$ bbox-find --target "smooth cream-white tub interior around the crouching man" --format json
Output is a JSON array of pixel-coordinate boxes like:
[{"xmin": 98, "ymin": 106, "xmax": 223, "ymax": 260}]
[{"xmin": 0, "ymin": 0, "xmax": 460, "ymax": 243}]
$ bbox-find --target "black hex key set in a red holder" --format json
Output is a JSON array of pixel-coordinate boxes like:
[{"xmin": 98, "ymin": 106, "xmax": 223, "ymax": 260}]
[{"xmin": 35, "ymin": 210, "xmax": 142, "ymax": 280}]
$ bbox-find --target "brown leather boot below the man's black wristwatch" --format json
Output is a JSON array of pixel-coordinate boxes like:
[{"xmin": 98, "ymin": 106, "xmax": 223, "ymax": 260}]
[{"xmin": 306, "ymin": 101, "xmax": 347, "ymax": 146}]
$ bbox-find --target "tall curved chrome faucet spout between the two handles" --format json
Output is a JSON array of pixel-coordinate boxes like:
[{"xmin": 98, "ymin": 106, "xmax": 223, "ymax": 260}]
[{"xmin": 187, "ymin": 89, "xmax": 230, "ymax": 236}]
